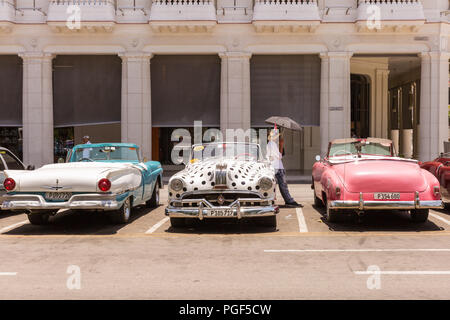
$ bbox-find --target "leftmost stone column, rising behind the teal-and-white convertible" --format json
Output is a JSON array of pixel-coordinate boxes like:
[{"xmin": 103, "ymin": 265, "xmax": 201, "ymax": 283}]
[{"xmin": 19, "ymin": 52, "xmax": 54, "ymax": 168}]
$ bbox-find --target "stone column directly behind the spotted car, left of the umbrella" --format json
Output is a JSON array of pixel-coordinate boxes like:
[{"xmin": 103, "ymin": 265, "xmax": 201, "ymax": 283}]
[{"xmin": 219, "ymin": 52, "xmax": 251, "ymax": 133}]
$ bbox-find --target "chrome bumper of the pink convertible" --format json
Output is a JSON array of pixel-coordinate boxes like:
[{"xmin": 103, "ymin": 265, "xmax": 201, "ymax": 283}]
[{"xmin": 330, "ymin": 193, "xmax": 444, "ymax": 211}]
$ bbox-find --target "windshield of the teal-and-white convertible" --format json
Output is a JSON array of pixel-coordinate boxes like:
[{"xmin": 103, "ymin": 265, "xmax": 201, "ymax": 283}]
[{"xmin": 71, "ymin": 146, "xmax": 139, "ymax": 162}]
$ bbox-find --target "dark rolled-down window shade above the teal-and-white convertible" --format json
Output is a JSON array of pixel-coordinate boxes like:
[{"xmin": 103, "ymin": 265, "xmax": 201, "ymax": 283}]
[{"xmin": 53, "ymin": 55, "xmax": 122, "ymax": 127}]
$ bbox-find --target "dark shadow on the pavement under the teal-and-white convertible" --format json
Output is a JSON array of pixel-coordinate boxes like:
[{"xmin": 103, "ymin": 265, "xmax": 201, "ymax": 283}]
[{"xmin": 3, "ymin": 207, "xmax": 156, "ymax": 236}]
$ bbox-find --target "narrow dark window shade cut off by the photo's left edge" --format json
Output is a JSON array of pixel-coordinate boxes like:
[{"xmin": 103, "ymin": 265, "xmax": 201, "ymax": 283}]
[{"xmin": 0, "ymin": 55, "xmax": 23, "ymax": 127}]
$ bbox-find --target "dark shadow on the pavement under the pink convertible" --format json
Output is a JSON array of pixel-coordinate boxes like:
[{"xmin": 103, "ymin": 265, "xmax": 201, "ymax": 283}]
[{"xmin": 313, "ymin": 206, "xmax": 444, "ymax": 232}]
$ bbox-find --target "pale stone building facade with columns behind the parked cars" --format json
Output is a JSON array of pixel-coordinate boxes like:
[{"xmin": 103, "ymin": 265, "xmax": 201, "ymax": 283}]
[{"xmin": 0, "ymin": 0, "xmax": 450, "ymax": 165}]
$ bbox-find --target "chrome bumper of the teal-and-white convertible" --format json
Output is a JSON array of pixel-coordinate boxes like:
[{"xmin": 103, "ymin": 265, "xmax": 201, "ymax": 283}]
[{"xmin": 1, "ymin": 194, "xmax": 121, "ymax": 210}]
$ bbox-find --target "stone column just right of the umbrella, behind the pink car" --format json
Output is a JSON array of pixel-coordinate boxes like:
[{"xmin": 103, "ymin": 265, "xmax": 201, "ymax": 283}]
[{"xmin": 320, "ymin": 52, "xmax": 353, "ymax": 156}]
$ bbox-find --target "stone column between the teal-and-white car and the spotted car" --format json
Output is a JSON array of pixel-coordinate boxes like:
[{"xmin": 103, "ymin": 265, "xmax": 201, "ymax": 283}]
[{"xmin": 119, "ymin": 52, "xmax": 152, "ymax": 160}]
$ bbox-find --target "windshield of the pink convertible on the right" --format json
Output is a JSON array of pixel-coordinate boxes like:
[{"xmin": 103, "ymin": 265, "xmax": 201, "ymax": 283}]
[{"xmin": 328, "ymin": 141, "xmax": 392, "ymax": 157}]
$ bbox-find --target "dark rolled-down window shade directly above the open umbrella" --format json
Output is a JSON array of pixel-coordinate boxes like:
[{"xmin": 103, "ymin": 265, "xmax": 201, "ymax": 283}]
[{"xmin": 250, "ymin": 55, "xmax": 320, "ymax": 127}]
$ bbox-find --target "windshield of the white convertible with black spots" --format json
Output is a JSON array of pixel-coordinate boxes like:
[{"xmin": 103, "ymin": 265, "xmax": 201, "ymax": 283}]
[{"xmin": 191, "ymin": 143, "xmax": 261, "ymax": 163}]
